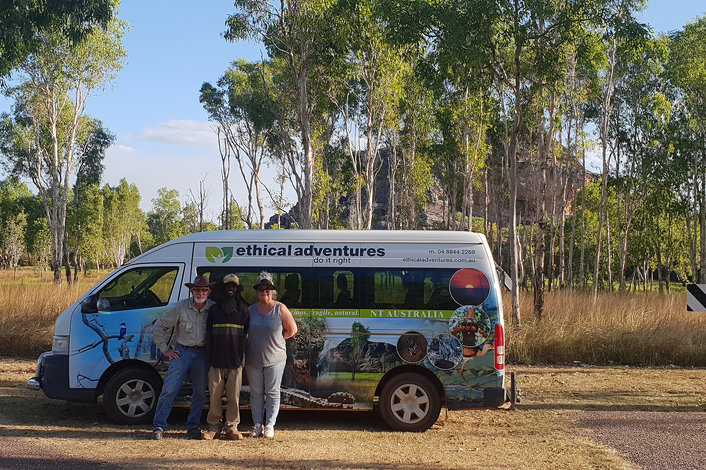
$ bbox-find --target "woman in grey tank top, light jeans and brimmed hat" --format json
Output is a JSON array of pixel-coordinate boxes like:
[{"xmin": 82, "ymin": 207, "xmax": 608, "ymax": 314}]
[{"xmin": 245, "ymin": 271, "xmax": 297, "ymax": 437}]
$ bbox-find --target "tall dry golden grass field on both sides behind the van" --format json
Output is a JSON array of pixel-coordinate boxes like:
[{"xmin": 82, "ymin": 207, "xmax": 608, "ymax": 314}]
[{"xmin": 0, "ymin": 270, "xmax": 706, "ymax": 368}]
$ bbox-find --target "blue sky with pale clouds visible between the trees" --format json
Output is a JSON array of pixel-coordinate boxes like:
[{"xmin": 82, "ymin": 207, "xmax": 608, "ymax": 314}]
[{"xmin": 0, "ymin": 0, "xmax": 706, "ymax": 220}]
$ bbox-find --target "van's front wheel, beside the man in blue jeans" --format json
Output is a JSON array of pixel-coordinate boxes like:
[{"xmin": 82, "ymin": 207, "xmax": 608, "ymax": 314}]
[{"xmin": 103, "ymin": 369, "xmax": 162, "ymax": 424}]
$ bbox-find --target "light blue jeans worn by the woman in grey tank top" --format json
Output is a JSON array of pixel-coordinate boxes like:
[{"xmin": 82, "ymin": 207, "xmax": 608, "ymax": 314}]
[{"xmin": 245, "ymin": 362, "xmax": 286, "ymax": 426}]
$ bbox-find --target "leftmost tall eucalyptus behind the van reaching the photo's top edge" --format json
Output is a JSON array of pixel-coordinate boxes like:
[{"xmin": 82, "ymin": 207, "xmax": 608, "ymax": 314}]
[{"xmin": 225, "ymin": 0, "xmax": 332, "ymax": 228}]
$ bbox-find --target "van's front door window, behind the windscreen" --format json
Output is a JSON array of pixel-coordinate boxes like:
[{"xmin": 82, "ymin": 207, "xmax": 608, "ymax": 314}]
[{"xmin": 98, "ymin": 266, "xmax": 179, "ymax": 312}]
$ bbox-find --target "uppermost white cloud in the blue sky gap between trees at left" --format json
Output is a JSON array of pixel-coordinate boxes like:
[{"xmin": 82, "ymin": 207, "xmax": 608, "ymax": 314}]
[{"xmin": 125, "ymin": 119, "xmax": 218, "ymax": 148}]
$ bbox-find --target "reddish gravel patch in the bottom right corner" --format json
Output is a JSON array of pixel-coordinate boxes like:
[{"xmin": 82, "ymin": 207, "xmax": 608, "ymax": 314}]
[{"xmin": 577, "ymin": 411, "xmax": 706, "ymax": 470}]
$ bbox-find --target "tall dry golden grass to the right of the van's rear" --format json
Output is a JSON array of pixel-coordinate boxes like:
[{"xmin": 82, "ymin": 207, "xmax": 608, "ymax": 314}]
[{"xmin": 504, "ymin": 291, "xmax": 706, "ymax": 367}]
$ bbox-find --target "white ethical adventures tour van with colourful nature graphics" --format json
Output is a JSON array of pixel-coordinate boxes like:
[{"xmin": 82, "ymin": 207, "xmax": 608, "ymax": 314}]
[{"xmin": 28, "ymin": 230, "xmax": 516, "ymax": 431}]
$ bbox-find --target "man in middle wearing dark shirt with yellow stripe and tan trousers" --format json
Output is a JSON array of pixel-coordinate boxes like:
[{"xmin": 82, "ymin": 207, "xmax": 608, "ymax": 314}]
[{"xmin": 203, "ymin": 274, "xmax": 250, "ymax": 440}]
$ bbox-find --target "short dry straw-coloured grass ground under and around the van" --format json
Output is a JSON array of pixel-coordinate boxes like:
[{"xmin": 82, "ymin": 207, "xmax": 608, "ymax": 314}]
[{"xmin": 13, "ymin": 358, "xmax": 706, "ymax": 470}]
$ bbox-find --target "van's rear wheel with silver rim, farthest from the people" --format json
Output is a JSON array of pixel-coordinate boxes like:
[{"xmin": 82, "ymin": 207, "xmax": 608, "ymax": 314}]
[{"xmin": 380, "ymin": 372, "xmax": 441, "ymax": 432}]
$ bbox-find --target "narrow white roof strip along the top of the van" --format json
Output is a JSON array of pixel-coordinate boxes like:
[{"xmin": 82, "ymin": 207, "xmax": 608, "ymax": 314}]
[{"xmin": 166, "ymin": 230, "xmax": 485, "ymax": 244}]
